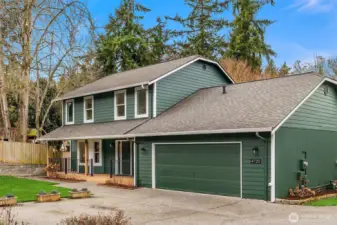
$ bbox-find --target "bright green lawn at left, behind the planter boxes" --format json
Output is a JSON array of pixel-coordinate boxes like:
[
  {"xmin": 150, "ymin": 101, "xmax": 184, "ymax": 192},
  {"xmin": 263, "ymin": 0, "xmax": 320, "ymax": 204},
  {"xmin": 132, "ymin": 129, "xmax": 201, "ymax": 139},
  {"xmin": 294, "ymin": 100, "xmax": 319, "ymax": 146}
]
[{"xmin": 0, "ymin": 176, "xmax": 71, "ymax": 202}]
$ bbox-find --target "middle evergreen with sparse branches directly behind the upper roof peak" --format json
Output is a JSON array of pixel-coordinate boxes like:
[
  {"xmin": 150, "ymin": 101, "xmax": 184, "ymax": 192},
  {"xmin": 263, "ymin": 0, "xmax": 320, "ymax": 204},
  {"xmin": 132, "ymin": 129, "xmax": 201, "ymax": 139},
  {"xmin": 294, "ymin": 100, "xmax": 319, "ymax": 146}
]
[{"xmin": 166, "ymin": 0, "xmax": 228, "ymax": 59}]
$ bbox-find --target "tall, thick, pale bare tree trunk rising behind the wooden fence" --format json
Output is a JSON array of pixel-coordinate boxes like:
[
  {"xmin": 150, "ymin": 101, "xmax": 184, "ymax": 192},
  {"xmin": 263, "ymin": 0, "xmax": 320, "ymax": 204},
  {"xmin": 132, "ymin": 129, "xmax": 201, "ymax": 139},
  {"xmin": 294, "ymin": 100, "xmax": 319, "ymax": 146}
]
[{"xmin": 19, "ymin": 0, "xmax": 33, "ymax": 142}]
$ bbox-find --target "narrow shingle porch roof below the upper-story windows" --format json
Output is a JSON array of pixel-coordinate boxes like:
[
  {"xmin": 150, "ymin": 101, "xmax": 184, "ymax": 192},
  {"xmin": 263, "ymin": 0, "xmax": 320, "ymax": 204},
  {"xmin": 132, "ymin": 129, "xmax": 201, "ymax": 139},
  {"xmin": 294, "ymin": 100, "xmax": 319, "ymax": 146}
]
[{"xmin": 39, "ymin": 119, "xmax": 146, "ymax": 141}]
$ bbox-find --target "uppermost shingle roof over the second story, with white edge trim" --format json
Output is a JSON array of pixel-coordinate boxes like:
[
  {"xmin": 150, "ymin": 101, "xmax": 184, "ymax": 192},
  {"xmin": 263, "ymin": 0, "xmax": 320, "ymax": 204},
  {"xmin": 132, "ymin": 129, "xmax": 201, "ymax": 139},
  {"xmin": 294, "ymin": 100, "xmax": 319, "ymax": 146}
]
[{"xmin": 57, "ymin": 56, "xmax": 233, "ymax": 100}]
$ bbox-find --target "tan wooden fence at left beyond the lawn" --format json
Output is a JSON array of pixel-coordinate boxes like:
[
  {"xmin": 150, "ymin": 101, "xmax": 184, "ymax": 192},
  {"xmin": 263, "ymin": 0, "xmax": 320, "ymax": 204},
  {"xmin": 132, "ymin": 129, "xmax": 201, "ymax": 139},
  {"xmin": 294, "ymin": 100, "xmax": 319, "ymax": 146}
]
[{"xmin": 0, "ymin": 141, "xmax": 52, "ymax": 165}]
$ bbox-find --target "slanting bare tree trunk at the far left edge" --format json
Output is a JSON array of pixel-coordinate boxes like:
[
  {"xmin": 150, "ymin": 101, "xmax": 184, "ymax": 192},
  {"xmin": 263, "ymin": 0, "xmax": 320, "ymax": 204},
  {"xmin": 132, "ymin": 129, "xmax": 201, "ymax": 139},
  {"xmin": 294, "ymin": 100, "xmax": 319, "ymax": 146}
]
[{"xmin": 0, "ymin": 11, "xmax": 11, "ymax": 139}]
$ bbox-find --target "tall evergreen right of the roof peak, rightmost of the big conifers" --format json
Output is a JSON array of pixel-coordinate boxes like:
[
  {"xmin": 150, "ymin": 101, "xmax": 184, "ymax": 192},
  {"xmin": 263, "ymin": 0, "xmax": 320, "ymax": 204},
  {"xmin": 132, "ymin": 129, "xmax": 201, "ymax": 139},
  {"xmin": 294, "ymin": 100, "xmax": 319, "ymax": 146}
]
[{"xmin": 227, "ymin": 0, "xmax": 276, "ymax": 69}]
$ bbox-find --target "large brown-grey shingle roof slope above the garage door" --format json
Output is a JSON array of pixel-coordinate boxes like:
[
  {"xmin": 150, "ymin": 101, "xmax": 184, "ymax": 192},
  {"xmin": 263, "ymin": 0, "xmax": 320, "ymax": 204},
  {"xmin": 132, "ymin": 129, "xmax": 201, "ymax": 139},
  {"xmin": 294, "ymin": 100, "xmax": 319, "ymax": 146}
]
[{"xmin": 128, "ymin": 73, "xmax": 324, "ymax": 136}]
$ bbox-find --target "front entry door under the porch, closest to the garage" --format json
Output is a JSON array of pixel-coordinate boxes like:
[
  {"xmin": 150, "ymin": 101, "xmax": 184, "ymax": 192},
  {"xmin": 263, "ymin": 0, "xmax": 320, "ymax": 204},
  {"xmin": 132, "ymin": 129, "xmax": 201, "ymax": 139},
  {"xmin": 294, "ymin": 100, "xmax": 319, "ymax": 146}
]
[{"xmin": 115, "ymin": 141, "xmax": 133, "ymax": 175}]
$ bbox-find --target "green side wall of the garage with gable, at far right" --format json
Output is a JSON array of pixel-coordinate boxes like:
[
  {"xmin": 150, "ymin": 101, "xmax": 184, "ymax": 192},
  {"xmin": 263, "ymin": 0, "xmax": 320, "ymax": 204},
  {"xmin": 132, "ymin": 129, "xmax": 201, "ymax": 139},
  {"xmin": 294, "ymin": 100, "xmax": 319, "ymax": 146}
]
[{"xmin": 275, "ymin": 83, "xmax": 337, "ymax": 197}]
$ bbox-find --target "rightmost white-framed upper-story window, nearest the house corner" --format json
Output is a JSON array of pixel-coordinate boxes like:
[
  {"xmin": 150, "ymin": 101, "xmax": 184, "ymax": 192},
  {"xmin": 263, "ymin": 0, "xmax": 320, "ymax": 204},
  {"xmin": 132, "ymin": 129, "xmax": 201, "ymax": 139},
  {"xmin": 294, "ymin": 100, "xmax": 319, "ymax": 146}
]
[{"xmin": 135, "ymin": 87, "xmax": 149, "ymax": 118}]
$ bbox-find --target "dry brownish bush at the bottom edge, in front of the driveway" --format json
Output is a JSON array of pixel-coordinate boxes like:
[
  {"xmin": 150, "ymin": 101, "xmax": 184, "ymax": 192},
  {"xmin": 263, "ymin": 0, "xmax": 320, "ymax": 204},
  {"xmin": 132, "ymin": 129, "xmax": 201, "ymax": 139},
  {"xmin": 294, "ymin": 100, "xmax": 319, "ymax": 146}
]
[{"xmin": 61, "ymin": 211, "xmax": 131, "ymax": 225}]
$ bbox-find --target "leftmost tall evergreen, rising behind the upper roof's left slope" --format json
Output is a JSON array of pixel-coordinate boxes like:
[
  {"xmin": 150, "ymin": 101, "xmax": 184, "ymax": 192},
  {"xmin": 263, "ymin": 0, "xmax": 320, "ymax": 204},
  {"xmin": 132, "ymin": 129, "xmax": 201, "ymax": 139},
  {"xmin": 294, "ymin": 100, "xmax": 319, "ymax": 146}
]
[{"xmin": 97, "ymin": 0, "xmax": 162, "ymax": 74}]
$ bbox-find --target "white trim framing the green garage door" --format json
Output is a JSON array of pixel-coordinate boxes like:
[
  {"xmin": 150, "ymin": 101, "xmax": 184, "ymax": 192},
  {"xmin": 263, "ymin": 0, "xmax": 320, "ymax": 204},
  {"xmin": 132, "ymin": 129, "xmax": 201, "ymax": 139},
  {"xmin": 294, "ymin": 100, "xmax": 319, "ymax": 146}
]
[{"xmin": 152, "ymin": 141, "xmax": 242, "ymax": 198}]
